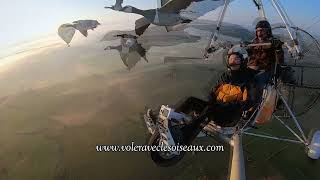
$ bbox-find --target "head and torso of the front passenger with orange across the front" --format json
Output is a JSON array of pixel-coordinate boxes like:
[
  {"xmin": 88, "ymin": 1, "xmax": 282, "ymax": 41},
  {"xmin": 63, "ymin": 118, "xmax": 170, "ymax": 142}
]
[{"xmin": 209, "ymin": 48, "xmax": 257, "ymax": 124}]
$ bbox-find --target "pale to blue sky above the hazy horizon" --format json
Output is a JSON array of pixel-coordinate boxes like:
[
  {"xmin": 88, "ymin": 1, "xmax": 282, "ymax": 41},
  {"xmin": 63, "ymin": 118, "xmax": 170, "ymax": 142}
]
[{"xmin": 0, "ymin": 0, "xmax": 320, "ymax": 48}]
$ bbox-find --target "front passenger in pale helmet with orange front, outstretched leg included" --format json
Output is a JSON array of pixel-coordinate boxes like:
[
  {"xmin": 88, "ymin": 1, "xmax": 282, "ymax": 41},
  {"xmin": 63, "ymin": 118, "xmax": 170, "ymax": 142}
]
[{"xmin": 170, "ymin": 48, "xmax": 256, "ymax": 126}]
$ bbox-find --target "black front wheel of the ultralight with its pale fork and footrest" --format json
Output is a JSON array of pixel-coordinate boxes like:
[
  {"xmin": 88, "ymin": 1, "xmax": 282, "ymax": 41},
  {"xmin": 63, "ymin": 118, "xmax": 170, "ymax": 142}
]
[{"xmin": 144, "ymin": 98, "xmax": 208, "ymax": 167}]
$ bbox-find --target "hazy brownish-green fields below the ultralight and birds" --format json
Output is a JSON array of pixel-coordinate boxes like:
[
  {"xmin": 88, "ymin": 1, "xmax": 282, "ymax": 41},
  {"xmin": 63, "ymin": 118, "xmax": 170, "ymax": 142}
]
[{"xmin": 0, "ymin": 34, "xmax": 320, "ymax": 180}]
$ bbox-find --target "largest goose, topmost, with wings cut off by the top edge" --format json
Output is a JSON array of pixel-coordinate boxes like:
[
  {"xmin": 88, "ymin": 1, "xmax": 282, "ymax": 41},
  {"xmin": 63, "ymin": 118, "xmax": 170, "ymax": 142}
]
[{"xmin": 106, "ymin": 0, "xmax": 232, "ymax": 36}]
